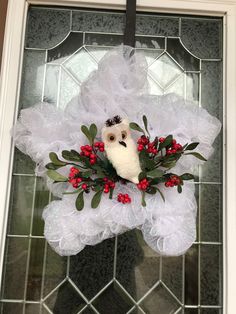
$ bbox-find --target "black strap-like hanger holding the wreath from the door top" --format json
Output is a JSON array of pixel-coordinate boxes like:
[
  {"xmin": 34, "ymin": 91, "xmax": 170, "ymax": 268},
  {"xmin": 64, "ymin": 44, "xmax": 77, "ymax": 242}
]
[{"xmin": 123, "ymin": 0, "xmax": 136, "ymax": 47}]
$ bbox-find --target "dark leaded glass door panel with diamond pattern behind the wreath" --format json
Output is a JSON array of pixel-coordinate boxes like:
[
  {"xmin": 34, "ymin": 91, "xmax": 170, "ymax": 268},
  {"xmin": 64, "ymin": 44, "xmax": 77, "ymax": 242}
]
[{"xmin": 0, "ymin": 7, "xmax": 223, "ymax": 314}]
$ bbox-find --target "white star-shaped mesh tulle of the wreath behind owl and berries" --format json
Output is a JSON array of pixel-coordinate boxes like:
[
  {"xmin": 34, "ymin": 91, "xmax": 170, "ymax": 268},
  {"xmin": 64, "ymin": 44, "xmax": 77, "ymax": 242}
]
[{"xmin": 13, "ymin": 46, "xmax": 221, "ymax": 255}]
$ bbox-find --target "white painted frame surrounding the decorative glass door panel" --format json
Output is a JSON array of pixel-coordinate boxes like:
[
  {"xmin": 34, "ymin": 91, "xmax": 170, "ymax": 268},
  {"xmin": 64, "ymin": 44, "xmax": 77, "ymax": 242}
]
[{"xmin": 0, "ymin": 0, "xmax": 236, "ymax": 314}]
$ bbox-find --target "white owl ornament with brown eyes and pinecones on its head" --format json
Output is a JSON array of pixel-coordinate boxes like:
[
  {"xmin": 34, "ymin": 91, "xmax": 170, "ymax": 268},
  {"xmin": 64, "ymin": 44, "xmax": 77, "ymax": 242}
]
[{"xmin": 102, "ymin": 116, "xmax": 141, "ymax": 184}]
